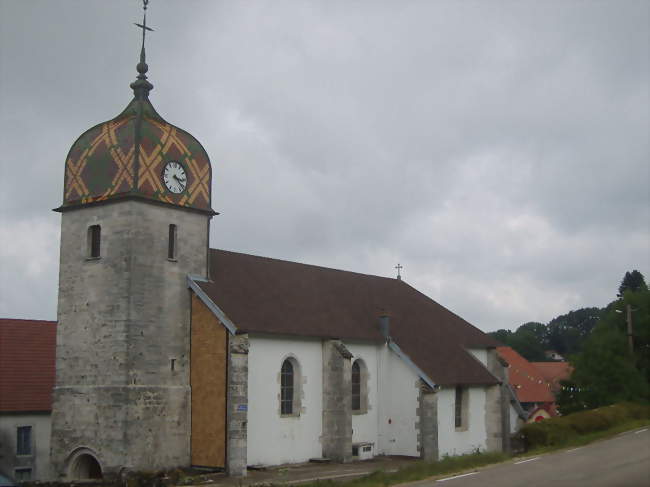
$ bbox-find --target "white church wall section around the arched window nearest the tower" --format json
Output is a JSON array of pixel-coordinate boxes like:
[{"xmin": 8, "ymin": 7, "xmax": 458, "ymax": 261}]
[{"xmin": 248, "ymin": 335, "xmax": 323, "ymax": 465}]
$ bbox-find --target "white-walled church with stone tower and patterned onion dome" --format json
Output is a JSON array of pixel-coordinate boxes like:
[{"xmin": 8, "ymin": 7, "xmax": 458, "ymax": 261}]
[{"xmin": 44, "ymin": 5, "xmax": 517, "ymax": 480}]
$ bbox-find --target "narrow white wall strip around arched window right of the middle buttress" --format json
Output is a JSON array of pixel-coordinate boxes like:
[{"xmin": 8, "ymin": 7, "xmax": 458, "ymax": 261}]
[{"xmin": 345, "ymin": 342, "xmax": 378, "ymax": 454}]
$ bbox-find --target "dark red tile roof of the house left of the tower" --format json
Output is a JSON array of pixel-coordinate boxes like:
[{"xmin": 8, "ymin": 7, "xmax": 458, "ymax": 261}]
[{"xmin": 0, "ymin": 318, "xmax": 56, "ymax": 412}]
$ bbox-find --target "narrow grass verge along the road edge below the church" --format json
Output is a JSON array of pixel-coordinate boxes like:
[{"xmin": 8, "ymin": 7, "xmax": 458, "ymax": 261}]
[{"xmin": 288, "ymin": 419, "xmax": 650, "ymax": 487}]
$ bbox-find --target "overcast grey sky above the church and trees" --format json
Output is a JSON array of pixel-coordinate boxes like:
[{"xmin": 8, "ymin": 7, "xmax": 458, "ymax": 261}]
[{"xmin": 0, "ymin": 0, "xmax": 650, "ymax": 331}]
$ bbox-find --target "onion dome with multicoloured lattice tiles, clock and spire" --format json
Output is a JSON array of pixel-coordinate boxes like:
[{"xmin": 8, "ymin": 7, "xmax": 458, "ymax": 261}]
[{"xmin": 58, "ymin": 24, "xmax": 213, "ymax": 213}]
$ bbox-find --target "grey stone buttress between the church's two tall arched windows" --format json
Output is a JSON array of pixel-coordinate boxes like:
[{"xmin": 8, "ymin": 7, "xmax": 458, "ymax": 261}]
[{"xmin": 321, "ymin": 340, "xmax": 352, "ymax": 462}]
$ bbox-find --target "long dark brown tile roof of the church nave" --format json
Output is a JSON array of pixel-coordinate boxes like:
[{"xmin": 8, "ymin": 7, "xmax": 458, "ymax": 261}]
[{"xmin": 199, "ymin": 250, "xmax": 499, "ymax": 385}]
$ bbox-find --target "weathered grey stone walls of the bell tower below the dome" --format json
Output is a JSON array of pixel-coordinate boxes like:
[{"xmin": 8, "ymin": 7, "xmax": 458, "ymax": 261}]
[{"xmin": 51, "ymin": 200, "xmax": 209, "ymax": 478}]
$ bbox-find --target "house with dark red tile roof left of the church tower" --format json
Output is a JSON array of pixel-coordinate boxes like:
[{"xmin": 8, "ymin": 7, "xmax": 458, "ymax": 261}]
[{"xmin": 0, "ymin": 318, "xmax": 56, "ymax": 482}]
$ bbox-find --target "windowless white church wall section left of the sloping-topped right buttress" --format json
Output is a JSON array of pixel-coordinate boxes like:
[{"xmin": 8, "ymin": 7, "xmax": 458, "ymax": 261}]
[{"xmin": 377, "ymin": 346, "xmax": 420, "ymax": 457}]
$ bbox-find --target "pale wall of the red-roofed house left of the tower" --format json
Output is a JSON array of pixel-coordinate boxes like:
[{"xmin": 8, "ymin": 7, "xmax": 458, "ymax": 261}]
[{"xmin": 0, "ymin": 413, "xmax": 51, "ymax": 480}]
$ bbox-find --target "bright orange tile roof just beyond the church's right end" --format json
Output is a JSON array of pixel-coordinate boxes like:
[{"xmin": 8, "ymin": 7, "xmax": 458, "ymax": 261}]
[{"xmin": 497, "ymin": 347, "xmax": 555, "ymax": 403}]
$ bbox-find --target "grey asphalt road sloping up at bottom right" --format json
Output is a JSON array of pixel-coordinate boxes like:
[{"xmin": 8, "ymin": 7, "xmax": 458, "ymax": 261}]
[{"xmin": 409, "ymin": 428, "xmax": 650, "ymax": 487}]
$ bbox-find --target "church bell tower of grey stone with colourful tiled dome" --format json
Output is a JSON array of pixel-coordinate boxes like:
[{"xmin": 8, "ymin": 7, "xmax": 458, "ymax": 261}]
[{"xmin": 51, "ymin": 14, "xmax": 215, "ymax": 479}]
